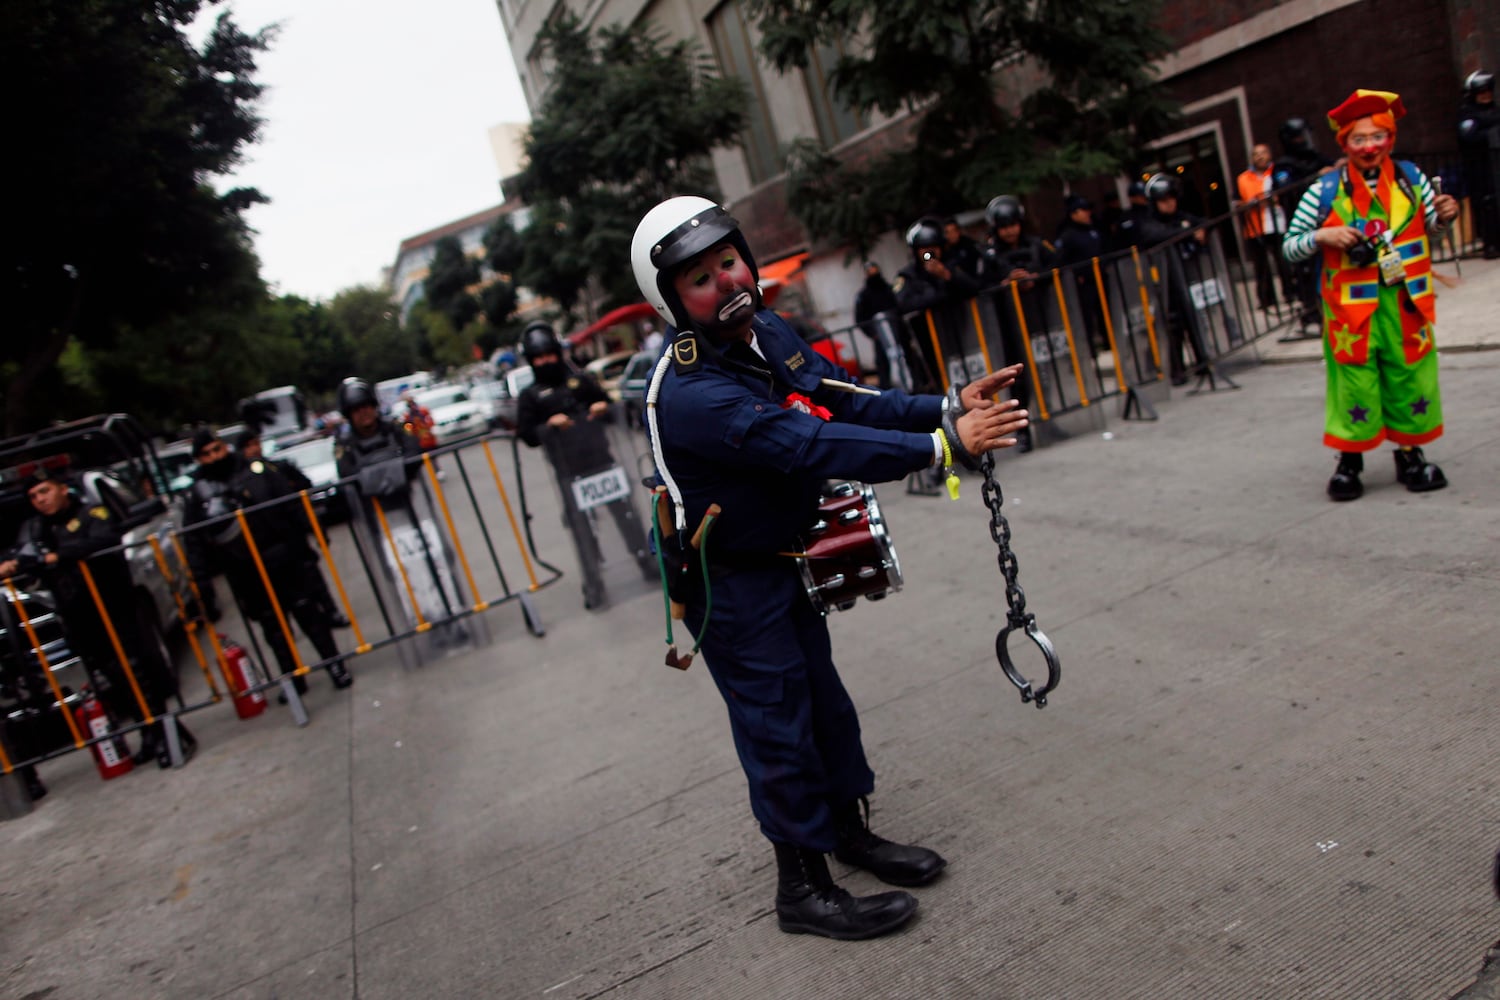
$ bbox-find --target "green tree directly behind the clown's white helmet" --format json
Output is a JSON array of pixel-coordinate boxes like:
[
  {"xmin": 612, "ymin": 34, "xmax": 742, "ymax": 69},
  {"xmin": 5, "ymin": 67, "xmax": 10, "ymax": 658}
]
[{"xmin": 510, "ymin": 15, "xmax": 746, "ymax": 319}]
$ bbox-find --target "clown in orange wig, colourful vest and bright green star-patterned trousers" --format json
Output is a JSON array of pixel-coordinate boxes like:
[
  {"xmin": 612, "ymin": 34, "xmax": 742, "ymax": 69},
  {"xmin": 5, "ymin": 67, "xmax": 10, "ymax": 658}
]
[{"xmin": 1281, "ymin": 90, "xmax": 1458, "ymax": 501}]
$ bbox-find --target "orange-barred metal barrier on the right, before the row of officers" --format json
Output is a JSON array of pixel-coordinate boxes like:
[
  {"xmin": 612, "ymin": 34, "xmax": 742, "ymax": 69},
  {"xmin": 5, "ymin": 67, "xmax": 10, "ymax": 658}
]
[{"xmin": 831, "ymin": 164, "xmax": 1461, "ymax": 424}]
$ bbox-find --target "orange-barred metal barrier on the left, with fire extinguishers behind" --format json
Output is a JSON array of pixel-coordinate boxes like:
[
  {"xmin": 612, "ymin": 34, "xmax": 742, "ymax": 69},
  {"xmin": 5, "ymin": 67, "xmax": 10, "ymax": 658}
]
[{"xmin": 0, "ymin": 435, "xmax": 563, "ymax": 791}]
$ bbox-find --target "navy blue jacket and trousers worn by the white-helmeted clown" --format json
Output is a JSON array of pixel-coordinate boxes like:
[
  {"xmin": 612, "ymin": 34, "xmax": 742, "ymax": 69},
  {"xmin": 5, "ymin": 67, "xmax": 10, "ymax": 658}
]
[{"xmin": 657, "ymin": 310, "xmax": 942, "ymax": 852}]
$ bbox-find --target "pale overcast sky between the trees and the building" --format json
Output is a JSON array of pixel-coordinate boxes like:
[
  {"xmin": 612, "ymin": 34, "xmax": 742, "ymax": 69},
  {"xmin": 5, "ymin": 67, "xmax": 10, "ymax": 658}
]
[{"xmin": 207, "ymin": 0, "xmax": 528, "ymax": 300}]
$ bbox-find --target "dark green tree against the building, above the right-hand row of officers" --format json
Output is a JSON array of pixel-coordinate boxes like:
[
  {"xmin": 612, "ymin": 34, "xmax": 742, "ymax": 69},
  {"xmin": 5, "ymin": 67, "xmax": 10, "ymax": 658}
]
[{"xmin": 744, "ymin": 0, "xmax": 1173, "ymax": 249}]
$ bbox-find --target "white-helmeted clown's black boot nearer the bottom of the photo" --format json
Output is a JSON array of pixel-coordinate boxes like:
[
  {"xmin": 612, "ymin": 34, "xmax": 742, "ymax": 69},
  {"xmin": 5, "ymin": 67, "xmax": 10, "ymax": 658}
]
[{"xmin": 774, "ymin": 844, "xmax": 917, "ymax": 942}]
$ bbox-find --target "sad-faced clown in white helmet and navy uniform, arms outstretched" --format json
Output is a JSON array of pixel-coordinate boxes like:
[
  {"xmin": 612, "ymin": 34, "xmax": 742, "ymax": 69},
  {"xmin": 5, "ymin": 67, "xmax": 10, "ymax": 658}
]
[{"xmin": 630, "ymin": 198, "xmax": 1028, "ymax": 940}]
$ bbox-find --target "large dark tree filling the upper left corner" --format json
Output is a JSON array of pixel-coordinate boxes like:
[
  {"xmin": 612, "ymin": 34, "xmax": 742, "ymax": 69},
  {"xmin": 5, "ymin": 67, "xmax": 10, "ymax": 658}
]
[{"xmin": 0, "ymin": 0, "xmax": 272, "ymax": 432}]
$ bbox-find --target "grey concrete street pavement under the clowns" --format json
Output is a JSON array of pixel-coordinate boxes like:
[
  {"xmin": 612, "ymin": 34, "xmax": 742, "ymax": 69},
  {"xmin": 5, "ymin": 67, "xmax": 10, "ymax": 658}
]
[{"xmin": 0, "ymin": 262, "xmax": 1500, "ymax": 1000}]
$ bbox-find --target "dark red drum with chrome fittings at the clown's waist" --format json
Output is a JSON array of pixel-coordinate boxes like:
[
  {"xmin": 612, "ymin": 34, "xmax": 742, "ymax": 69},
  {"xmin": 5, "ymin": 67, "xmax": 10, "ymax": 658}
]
[{"xmin": 797, "ymin": 483, "xmax": 902, "ymax": 615}]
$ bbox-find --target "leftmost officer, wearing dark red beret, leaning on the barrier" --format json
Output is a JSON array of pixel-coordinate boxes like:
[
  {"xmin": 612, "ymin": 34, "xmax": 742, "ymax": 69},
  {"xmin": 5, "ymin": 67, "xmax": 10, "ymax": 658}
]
[{"xmin": 0, "ymin": 468, "xmax": 198, "ymax": 768}]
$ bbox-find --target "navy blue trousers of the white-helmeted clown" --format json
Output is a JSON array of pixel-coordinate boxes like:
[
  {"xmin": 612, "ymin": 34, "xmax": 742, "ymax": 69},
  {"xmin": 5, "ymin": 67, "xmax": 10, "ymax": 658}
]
[{"xmin": 686, "ymin": 559, "xmax": 875, "ymax": 852}]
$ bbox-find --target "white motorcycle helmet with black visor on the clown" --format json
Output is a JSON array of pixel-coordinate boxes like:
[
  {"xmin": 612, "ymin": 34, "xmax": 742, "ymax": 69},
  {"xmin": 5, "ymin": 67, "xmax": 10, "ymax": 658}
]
[{"xmin": 630, "ymin": 195, "xmax": 761, "ymax": 330}]
